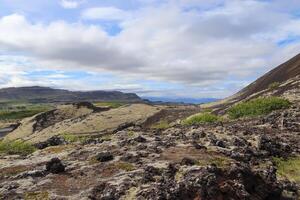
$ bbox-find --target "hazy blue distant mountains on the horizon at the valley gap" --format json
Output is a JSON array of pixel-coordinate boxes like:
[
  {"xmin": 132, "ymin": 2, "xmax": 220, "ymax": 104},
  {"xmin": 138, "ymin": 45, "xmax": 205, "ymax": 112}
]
[{"xmin": 145, "ymin": 97, "xmax": 219, "ymax": 104}]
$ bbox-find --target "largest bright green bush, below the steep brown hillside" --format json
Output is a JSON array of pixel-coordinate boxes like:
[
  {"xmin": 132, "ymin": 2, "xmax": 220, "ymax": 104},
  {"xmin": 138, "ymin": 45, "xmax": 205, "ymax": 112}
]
[{"xmin": 228, "ymin": 97, "xmax": 291, "ymax": 119}]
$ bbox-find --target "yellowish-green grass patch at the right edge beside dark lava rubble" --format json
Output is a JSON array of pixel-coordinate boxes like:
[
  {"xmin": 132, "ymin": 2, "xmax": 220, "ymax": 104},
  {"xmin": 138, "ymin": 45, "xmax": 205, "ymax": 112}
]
[{"xmin": 273, "ymin": 157, "xmax": 300, "ymax": 183}]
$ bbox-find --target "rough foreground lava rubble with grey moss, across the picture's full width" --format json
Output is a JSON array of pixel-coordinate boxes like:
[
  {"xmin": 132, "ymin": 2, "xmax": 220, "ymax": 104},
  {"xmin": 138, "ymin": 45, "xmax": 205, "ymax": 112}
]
[{"xmin": 0, "ymin": 106, "xmax": 300, "ymax": 200}]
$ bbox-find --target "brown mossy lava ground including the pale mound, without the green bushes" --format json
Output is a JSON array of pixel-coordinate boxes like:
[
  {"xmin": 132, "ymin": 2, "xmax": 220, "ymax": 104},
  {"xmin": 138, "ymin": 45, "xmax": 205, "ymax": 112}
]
[{"xmin": 0, "ymin": 55, "xmax": 300, "ymax": 200}]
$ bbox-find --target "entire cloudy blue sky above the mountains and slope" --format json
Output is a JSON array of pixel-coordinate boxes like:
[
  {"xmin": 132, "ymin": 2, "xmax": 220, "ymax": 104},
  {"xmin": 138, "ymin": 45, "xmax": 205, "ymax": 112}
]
[{"xmin": 0, "ymin": 0, "xmax": 300, "ymax": 98}]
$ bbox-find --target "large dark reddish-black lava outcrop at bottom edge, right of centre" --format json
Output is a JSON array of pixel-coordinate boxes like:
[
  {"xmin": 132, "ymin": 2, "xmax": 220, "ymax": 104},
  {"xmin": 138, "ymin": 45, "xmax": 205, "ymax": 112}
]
[{"xmin": 137, "ymin": 165, "xmax": 288, "ymax": 200}]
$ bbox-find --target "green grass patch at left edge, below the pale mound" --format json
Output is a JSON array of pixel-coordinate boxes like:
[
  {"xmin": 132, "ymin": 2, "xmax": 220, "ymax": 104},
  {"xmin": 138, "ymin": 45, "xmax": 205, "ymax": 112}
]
[{"xmin": 0, "ymin": 141, "xmax": 36, "ymax": 156}]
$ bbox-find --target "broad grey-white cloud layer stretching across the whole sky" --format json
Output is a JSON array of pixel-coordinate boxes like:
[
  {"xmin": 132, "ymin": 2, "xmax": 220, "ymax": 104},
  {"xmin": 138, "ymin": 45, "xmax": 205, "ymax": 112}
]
[{"xmin": 0, "ymin": 0, "xmax": 300, "ymax": 97}]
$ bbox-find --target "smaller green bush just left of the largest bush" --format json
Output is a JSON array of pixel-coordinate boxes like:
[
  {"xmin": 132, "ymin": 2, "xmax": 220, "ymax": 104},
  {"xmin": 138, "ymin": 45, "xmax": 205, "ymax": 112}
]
[{"xmin": 182, "ymin": 112, "xmax": 221, "ymax": 125}]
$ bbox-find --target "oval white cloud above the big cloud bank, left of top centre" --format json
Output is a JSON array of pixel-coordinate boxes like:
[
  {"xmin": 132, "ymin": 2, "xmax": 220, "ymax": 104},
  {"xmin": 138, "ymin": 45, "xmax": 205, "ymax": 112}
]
[{"xmin": 81, "ymin": 7, "xmax": 129, "ymax": 20}]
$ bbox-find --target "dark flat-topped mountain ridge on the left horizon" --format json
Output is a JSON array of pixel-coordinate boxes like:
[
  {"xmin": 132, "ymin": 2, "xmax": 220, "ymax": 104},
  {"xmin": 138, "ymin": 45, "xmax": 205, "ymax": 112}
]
[{"xmin": 0, "ymin": 86, "xmax": 142, "ymax": 103}]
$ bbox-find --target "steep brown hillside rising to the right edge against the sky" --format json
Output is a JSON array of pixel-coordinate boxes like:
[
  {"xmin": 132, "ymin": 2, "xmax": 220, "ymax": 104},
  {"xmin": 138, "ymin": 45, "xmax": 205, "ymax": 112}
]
[{"xmin": 202, "ymin": 54, "xmax": 300, "ymax": 111}]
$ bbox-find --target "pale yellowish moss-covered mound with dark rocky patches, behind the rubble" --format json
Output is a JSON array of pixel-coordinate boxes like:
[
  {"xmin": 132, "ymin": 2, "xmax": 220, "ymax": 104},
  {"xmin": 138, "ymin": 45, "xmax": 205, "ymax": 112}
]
[{"xmin": 4, "ymin": 103, "xmax": 161, "ymax": 143}]
